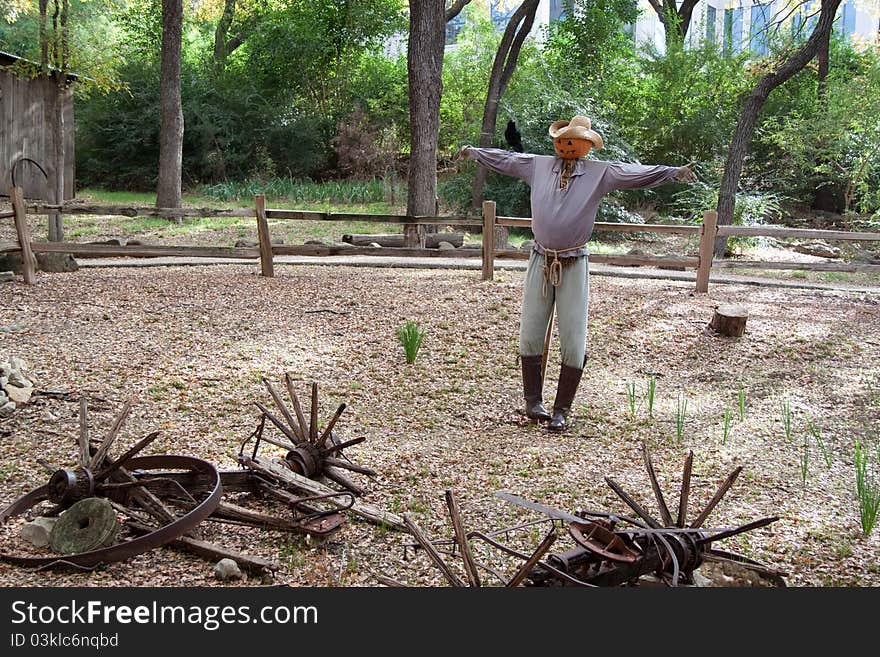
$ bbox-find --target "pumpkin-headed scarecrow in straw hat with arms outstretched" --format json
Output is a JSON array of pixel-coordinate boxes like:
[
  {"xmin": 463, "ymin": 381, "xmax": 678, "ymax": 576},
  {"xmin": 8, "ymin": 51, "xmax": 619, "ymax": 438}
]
[{"xmin": 459, "ymin": 116, "xmax": 697, "ymax": 431}]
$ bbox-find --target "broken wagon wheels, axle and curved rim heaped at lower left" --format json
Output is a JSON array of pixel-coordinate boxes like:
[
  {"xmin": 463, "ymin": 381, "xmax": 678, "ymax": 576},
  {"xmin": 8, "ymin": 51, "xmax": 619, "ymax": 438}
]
[{"xmin": 0, "ymin": 377, "xmax": 403, "ymax": 571}]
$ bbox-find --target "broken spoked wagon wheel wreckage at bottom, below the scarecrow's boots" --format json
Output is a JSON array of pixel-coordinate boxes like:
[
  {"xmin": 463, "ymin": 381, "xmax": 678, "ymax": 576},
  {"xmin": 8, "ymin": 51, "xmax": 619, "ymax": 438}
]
[{"xmin": 385, "ymin": 448, "xmax": 785, "ymax": 586}]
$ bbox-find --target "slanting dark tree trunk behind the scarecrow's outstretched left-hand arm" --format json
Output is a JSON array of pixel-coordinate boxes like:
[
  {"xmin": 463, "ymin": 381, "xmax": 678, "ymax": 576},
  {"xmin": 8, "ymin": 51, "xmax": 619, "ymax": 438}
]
[{"xmin": 471, "ymin": 0, "xmax": 539, "ymax": 212}]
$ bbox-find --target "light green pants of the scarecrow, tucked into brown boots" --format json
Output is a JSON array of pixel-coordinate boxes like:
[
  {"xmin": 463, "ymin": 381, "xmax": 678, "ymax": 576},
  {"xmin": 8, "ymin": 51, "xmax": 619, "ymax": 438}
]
[{"xmin": 519, "ymin": 251, "xmax": 590, "ymax": 369}]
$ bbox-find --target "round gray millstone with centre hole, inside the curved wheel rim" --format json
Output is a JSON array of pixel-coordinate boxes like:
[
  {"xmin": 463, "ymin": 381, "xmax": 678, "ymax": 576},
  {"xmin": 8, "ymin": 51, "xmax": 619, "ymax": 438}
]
[{"xmin": 49, "ymin": 497, "xmax": 119, "ymax": 554}]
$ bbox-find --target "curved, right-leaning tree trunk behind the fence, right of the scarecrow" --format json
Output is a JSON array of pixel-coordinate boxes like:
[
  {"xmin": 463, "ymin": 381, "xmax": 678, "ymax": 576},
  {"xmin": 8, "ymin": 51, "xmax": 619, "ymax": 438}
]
[{"xmin": 715, "ymin": 0, "xmax": 841, "ymax": 257}]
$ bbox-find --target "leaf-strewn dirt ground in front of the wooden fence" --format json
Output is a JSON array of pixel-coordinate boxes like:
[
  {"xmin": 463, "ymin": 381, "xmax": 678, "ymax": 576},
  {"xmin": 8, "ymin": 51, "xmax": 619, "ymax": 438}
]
[{"xmin": 0, "ymin": 265, "xmax": 880, "ymax": 586}]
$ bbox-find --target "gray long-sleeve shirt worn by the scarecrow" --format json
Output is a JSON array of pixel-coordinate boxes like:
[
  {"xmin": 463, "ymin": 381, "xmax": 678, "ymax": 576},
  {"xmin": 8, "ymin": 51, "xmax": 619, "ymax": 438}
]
[{"xmin": 467, "ymin": 146, "xmax": 678, "ymax": 257}]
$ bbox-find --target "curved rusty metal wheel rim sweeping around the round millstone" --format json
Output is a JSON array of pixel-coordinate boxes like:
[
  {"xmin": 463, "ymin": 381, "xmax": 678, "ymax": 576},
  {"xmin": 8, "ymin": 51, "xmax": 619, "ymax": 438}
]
[{"xmin": 0, "ymin": 454, "xmax": 223, "ymax": 568}]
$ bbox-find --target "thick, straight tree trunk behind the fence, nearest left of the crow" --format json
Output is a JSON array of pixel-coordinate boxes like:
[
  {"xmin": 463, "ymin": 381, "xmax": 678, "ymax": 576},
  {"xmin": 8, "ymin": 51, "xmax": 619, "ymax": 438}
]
[{"xmin": 404, "ymin": 0, "xmax": 446, "ymax": 247}]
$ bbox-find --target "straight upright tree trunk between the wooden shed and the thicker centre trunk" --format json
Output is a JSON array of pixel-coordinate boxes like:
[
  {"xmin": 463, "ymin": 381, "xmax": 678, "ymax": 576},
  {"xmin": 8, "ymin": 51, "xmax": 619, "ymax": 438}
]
[{"xmin": 156, "ymin": 0, "xmax": 183, "ymax": 208}]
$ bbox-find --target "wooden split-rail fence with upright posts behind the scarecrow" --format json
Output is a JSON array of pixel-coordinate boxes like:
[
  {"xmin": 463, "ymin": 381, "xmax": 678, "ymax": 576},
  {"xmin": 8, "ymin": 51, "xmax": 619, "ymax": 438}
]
[{"xmin": 0, "ymin": 189, "xmax": 880, "ymax": 292}]
